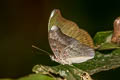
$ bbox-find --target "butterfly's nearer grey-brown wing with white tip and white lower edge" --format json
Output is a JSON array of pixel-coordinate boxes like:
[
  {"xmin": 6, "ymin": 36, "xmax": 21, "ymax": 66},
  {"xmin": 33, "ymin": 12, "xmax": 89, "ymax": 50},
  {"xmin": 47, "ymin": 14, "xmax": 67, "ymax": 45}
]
[{"xmin": 49, "ymin": 26, "xmax": 94, "ymax": 64}]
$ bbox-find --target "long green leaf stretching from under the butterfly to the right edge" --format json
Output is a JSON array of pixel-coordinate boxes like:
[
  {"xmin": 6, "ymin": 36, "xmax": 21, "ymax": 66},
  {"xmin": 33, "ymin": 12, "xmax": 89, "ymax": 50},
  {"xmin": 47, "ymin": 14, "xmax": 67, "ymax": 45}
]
[{"xmin": 74, "ymin": 49, "xmax": 120, "ymax": 75}]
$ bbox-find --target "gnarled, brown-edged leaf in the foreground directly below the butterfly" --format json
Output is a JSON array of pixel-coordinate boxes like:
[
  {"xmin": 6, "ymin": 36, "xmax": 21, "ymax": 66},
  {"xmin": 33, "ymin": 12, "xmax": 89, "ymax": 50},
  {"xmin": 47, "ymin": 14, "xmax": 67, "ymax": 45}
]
[{"xmin": 33, "ymin": 65, "xmax": 92, "ymax": 80}]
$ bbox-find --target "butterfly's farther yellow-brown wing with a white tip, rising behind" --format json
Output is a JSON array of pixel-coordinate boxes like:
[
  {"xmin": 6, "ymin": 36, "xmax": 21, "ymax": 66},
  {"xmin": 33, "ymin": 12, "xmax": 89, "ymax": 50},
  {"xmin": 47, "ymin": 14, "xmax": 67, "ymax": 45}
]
[{"xmin": 48, "ymin": 9, "xmax": 94, "ymax": 48}]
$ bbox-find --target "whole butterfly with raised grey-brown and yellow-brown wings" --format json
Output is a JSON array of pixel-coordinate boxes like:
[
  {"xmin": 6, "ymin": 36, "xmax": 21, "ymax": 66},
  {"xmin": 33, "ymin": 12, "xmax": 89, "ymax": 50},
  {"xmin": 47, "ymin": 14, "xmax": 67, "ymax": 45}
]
[{"xmin": 48, "ymin": 9, "xmax": 95, "ymax": 65}]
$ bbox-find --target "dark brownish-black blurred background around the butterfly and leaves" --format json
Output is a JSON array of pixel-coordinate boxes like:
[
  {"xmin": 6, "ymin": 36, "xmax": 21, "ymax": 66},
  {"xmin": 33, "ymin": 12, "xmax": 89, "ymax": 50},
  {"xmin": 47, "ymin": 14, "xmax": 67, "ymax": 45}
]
[{"xmin": 0, "ymin": 0, "xmax": 120, "ymax": 80}]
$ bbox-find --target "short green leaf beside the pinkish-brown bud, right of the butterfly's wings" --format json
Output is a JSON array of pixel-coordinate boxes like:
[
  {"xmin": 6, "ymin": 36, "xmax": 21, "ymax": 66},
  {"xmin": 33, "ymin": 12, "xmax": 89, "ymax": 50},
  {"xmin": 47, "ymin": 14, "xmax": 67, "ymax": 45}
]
[{"xmin": 94, "ymin": 31, "xmax": 120, "ymax": 50}]
